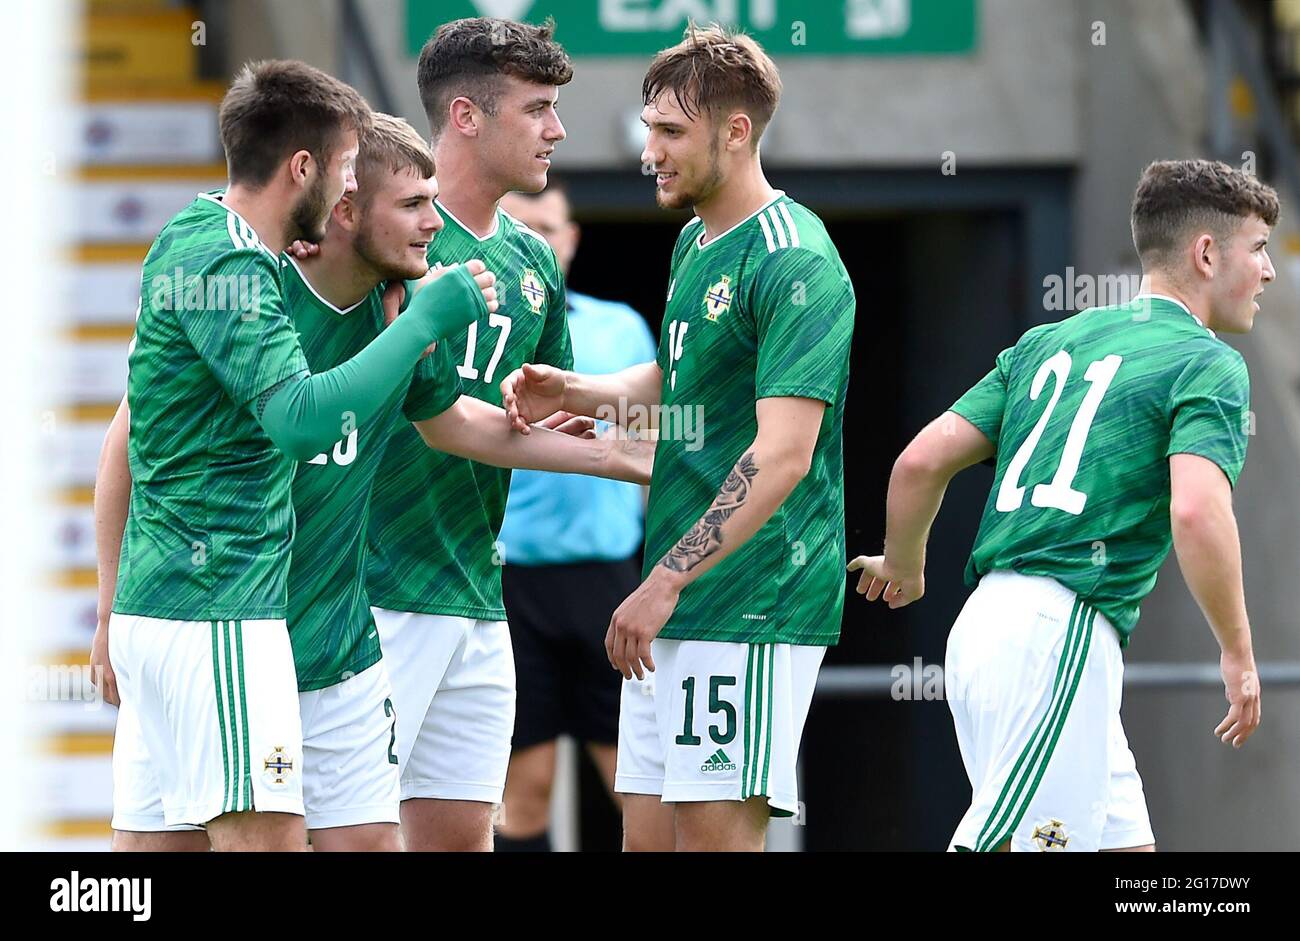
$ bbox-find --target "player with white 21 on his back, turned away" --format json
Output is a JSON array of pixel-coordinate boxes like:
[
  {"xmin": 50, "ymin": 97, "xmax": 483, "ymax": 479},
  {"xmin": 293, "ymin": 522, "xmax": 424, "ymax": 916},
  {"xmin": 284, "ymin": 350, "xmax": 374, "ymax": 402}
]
[{"xmin": 849, "ymin": 160, "xmax": 1278, "ymax": 851}]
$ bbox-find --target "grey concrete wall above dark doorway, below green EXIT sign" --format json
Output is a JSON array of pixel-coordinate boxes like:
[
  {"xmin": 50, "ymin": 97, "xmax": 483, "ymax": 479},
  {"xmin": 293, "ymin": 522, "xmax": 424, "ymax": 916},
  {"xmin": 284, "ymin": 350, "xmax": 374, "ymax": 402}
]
[{"xmin": 361, "ymin": 0, "xmax": 1087, "ymax": 169}]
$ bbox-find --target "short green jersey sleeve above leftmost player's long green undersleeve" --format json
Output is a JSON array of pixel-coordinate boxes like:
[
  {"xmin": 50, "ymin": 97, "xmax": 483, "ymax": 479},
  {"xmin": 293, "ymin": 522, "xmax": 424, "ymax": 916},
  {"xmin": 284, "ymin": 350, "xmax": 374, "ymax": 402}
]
[{"xmin": 177, "ymin": 250, "xmax": 308, "ymax": 406}]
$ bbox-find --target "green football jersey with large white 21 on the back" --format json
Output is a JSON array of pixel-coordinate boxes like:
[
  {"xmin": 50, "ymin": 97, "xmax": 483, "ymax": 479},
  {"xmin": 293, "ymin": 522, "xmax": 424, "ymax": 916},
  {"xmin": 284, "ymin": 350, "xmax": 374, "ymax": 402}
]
[{"xmin": 952, "ymin": 295, "xmax": 1251, "ymax": 645}]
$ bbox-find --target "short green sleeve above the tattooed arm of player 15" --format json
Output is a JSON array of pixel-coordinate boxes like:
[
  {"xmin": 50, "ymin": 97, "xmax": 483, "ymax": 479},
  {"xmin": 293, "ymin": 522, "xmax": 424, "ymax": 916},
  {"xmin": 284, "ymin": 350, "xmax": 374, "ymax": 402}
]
[{"xmin": 750, "ymin": 248, "xmax": 854, "ymax": 404}]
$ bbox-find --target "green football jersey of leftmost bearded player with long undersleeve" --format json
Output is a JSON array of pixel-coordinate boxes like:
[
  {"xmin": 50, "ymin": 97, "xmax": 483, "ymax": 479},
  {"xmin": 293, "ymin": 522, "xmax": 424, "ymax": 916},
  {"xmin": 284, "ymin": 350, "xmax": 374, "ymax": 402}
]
[{"xmin": 113, "ymin": 194, "xmax": 307, "ymax": 621}]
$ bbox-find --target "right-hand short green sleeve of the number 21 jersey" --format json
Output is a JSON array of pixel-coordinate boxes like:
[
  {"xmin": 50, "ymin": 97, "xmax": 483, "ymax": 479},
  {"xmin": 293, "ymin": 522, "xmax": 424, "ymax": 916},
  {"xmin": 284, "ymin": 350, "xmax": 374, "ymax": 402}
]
[{"xmin": 1166, "ymin": 347, "xmax": 1251, "ymax": 487}]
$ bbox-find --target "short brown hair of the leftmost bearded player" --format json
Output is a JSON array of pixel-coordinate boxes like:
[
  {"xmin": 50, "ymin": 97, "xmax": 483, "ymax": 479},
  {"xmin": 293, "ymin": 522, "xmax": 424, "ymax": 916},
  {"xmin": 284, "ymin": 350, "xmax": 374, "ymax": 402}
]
[{"xmin": 218, "ymin": 58, "xmax": 371, "ymax": 186}]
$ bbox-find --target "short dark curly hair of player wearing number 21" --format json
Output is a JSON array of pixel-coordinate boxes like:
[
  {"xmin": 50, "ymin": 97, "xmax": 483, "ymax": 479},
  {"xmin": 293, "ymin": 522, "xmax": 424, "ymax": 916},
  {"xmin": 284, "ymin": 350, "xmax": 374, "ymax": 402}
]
[{"xmin": 1131, "ymin": 160, "xmax": 1279, "ymax": 268}]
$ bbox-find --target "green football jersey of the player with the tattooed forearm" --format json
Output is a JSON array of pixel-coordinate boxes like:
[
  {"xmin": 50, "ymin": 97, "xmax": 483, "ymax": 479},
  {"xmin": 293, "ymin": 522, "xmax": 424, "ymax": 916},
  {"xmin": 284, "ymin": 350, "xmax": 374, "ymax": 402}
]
[{"xmin": 645, "ymin": 194, "xmax": 854, "ymax": 645}]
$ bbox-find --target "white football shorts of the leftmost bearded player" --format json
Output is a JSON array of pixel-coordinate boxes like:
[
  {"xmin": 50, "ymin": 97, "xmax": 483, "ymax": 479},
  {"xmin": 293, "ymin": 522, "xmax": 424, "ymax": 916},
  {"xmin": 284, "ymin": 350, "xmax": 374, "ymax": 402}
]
[{"xmin": 108, "ymin": 613, "xmax": 303, "ymax": 831}]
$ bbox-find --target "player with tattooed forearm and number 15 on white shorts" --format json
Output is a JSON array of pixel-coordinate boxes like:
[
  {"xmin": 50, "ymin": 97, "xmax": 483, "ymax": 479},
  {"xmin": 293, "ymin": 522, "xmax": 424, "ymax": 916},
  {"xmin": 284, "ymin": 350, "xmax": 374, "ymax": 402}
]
[{"xmin": 503, "ymin": 27, "xmax": 854, "ymax": 850}]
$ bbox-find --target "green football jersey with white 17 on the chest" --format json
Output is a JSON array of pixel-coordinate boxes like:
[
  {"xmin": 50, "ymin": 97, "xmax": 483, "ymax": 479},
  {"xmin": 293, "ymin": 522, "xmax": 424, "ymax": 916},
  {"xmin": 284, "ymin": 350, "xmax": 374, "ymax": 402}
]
[{"xmin": 368, "ymin": 204, "xmax": 573, "ymax": 620}]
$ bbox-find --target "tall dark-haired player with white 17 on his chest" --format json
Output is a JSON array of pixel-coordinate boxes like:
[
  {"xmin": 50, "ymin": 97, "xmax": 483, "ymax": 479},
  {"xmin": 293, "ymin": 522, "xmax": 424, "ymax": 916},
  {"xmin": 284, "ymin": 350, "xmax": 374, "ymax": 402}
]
[{"xmin": 356, "ymin": 18, "xmax": 572, "ymax": 850}]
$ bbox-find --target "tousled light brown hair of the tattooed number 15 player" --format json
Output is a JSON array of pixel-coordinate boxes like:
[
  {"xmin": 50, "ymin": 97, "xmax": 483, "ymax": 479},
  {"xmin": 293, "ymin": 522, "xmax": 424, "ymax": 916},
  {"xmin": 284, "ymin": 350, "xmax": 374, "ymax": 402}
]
[{"xmin": 641, "ymin": 23, "xmax": 781, "ymax": 147}]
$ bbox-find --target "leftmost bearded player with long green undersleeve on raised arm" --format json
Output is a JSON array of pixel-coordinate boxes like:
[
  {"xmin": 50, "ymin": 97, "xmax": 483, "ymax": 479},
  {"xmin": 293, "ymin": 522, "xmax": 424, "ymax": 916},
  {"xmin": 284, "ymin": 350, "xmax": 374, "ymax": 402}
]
[{"xmin": 94, "ymin": 61, "xmax": 495, "ymax": 850}]
